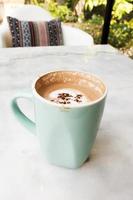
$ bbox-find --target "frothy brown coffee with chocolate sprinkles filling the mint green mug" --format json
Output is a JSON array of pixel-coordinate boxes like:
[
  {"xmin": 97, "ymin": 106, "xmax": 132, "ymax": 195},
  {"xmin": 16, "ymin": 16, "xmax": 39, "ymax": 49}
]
[{"xmin": 35, "ymin": 71, "xmax": 105, "ymax": 105}]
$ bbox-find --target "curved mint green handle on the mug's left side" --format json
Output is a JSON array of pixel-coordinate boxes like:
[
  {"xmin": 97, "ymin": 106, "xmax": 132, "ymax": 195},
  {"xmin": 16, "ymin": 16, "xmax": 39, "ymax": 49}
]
[{"xmin": 11, "ymin": 93, "xmax": 36, "ymax": 135}]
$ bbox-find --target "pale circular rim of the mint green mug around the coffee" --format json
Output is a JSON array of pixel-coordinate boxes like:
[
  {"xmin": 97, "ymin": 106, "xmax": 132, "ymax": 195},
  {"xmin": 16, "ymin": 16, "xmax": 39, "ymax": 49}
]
[{"xmin": 32, "ymin": 69, "xmax": 108, "ymax": 109}]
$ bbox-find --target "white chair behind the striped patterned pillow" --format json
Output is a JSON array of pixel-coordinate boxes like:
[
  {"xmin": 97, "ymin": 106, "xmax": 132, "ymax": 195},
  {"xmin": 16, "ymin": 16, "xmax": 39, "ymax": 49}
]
[{"xmin": 0, "ymin": 4, "xmax": 94, "ymax": 47}]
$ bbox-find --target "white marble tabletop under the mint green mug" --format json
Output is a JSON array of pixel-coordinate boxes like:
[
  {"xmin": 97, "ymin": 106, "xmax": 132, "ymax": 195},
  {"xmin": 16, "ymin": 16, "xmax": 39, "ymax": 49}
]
[{"xmin": 0, "ymin": 45, "xmax": 133, "ymax": 200}]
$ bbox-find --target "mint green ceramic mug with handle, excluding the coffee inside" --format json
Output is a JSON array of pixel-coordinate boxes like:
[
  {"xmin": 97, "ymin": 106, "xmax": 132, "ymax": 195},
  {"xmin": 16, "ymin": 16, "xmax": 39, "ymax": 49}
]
[{"xmin": 11, "ymin": 71, "xmax": 107, "ymax": 168}]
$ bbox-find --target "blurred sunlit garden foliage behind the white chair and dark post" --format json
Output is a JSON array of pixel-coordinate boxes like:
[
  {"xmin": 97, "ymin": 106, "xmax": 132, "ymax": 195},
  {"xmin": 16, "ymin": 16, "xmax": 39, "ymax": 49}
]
[{"xmin": 26, "ymin": 0, "xmax": 133, "ymax": 58}]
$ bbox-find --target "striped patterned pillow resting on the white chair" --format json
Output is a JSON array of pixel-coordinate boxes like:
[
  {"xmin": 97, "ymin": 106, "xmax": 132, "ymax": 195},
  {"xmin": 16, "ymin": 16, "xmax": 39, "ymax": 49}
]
[{"xmin": 7, "ymin": 17, "xmax": 63, "ymax": 47}]
